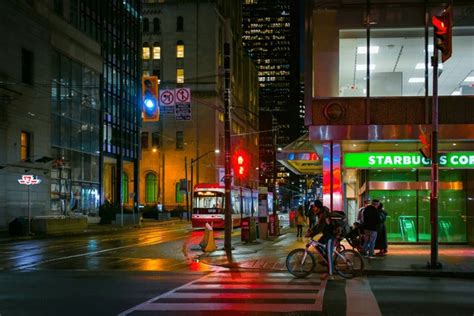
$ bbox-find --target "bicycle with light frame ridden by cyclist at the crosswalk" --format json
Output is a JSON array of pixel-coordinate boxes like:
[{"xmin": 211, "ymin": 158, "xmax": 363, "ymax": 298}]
[{"xmin": 286, "ymin": 238, "xmax": 364, "ymax": 279}]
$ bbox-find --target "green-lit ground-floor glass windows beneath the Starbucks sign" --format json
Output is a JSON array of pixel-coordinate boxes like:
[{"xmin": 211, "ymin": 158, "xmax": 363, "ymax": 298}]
[{"xmin": 368, "ymin": 169, "xmax": 467, "ymax": 243}]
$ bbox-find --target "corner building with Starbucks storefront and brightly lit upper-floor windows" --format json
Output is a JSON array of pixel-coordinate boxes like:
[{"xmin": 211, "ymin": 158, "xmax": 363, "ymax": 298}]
[{"xmin": 305, "ymin": 1, "xmax": 474, "ymax": 243}]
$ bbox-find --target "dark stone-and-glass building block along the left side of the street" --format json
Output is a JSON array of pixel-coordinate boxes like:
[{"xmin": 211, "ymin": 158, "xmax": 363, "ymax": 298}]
[{"xmin": 0, "ymin": 0, "xmax": 141, "ymax": 228}]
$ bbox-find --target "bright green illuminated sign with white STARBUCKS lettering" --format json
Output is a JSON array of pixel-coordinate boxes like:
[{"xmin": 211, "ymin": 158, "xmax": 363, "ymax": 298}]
[{"xmin": 343, "ymin": 151, "xmax": 474, "ymax": 169}]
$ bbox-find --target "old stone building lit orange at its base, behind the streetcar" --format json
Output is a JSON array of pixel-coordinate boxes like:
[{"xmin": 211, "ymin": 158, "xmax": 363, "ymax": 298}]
[{"xmin": 140, "ymin": 1, "xmax": 258, "ymax": 210}]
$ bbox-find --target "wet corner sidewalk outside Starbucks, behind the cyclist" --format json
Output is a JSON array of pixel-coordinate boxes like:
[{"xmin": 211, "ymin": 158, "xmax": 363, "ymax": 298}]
[{"xmin": 199, "ymin": 228, "xmax": 474, "ymax": 279}]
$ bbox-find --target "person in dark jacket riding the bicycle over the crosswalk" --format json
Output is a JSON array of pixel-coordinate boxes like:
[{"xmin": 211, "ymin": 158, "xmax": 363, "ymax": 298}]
[{"xmin": 305, "ymin": 200, "xmax": 337, "ymax": 275}]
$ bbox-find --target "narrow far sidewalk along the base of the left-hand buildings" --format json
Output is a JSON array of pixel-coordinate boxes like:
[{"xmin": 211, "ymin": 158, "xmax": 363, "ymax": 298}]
[{"xmin": 0, "ymin": 218, "xmax": 185, "ymax": 243}]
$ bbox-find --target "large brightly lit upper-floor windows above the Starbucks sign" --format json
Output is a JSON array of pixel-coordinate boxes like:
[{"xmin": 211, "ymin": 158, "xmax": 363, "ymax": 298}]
[{"xmin": 314, "ymin": 1, "xmax": 474, "ymax": 97}]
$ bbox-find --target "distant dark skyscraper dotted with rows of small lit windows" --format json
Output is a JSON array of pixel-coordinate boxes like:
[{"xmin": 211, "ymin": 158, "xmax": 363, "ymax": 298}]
[{"xmin": 242, "ymin": 0, "xmax": 303, "ymax": 195}]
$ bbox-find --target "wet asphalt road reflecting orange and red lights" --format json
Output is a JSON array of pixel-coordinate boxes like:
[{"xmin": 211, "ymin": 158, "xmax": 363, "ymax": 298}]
[{"xmin": 0, "ymin": 223, "xmax": 474, "ymax": 316}]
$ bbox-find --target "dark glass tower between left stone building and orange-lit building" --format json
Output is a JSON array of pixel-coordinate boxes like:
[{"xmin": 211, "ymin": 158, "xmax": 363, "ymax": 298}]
[{"xmin": 69, "ymin": 0, "xmax": 141, "ymax": 204}]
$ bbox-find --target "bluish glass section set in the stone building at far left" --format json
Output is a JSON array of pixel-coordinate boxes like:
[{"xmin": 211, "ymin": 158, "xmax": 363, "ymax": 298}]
[{"xmin": 51, "ymin": 52, "xmax": 100, "ymax": 214}]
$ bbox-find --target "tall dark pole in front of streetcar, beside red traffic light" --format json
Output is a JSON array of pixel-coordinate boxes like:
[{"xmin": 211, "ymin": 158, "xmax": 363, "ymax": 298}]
[{"xmin": 224, "ymin": 42, "xmax": 232, "ymax": 251}]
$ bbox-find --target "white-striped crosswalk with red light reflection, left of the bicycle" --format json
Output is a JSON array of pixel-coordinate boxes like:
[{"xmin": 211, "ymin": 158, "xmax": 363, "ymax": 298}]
[{"xmin": 120, "ymin": 271, "xmax": 327, "ymax": 315}]
